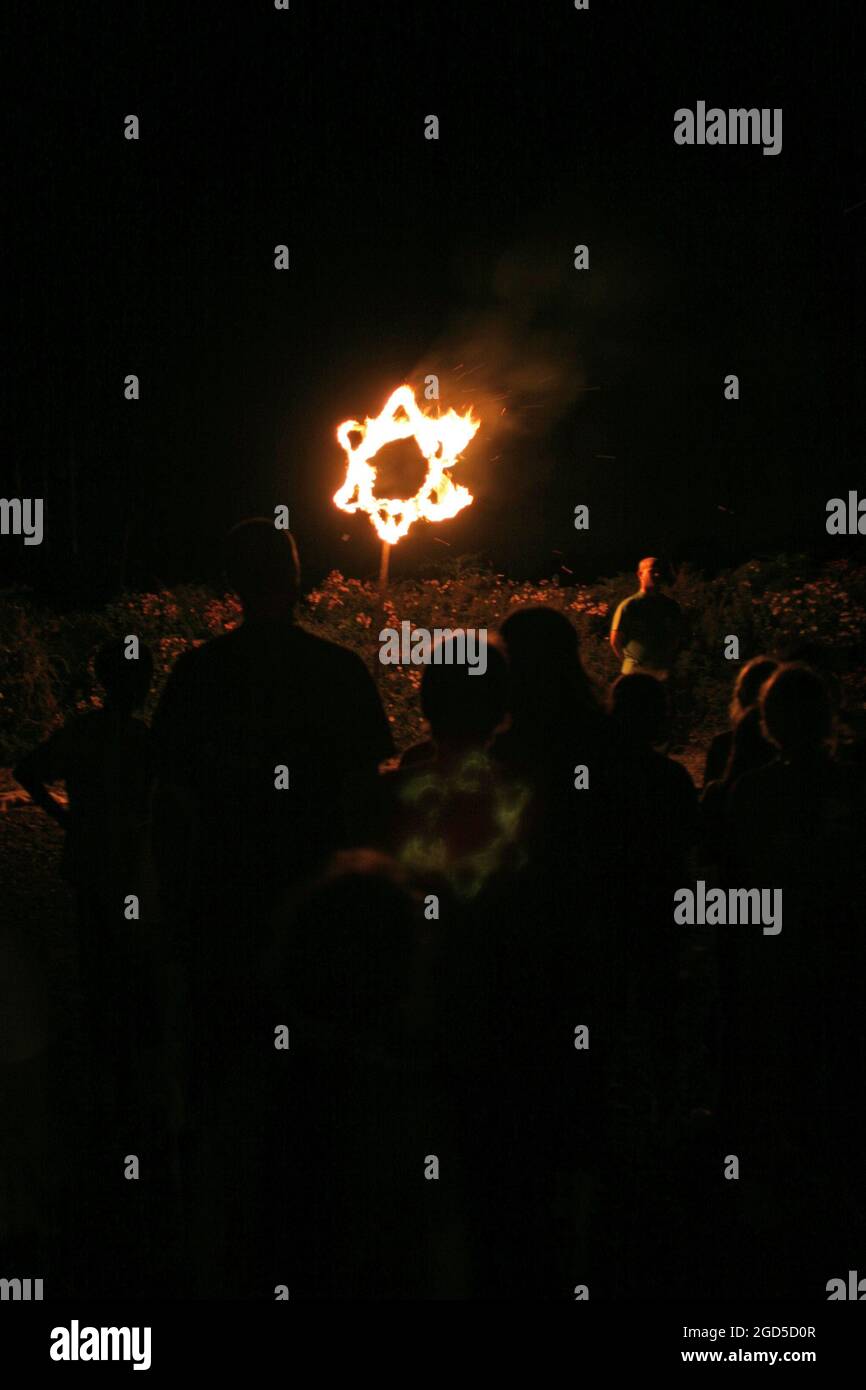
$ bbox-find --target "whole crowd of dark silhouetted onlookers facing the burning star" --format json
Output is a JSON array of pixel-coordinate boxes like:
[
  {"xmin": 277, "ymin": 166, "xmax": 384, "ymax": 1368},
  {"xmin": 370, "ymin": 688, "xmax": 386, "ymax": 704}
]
[{"xmin": 6, "ymin": 523, "xmax": 866, "ymax": 1298}]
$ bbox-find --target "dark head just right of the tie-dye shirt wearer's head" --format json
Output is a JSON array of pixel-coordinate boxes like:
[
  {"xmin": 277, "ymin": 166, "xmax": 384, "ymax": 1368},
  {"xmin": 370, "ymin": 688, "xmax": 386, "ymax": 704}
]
[{"xmin": 499, "ymin": 607, "xmax": 598, "ymax": 731}]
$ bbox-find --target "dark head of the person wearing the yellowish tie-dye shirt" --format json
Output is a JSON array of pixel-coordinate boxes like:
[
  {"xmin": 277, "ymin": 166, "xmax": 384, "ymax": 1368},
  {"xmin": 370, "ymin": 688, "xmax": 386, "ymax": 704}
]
[{"xmin": 421, "ymin": 632, "xmax": 509, "ymax": 745}]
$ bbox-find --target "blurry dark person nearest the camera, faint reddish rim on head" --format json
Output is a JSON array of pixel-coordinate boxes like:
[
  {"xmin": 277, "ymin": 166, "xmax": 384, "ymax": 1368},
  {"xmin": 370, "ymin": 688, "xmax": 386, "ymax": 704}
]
[{"xmin": 196, "ymin": 849, "xmax": 460, "ymax": 1301}]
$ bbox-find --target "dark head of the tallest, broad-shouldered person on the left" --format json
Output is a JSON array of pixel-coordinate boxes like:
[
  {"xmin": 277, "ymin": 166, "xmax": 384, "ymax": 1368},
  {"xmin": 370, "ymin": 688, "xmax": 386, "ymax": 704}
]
[{"xmin": 225, "ymin": 517, "xmax": 300, "ymax": 619}]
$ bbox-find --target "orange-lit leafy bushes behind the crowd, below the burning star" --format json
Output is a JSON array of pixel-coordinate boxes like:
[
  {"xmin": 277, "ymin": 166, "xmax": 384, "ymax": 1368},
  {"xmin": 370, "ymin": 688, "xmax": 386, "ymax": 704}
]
[{"xmin": 0, "ymin": 556, "xmax": 866, "ymax": 763}]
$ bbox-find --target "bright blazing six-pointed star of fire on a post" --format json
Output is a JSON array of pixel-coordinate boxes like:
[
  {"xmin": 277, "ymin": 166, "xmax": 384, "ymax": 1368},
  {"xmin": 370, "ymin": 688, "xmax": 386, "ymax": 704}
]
[{"xmin": 334, "ymin": 386, "xmax": 481, "ymax": 545}]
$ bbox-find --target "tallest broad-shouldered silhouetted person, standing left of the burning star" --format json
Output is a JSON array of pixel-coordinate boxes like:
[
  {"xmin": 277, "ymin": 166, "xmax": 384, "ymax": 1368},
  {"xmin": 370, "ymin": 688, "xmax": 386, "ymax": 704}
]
[{"xmin": 153, "ymin": 518, "xmax": 393, "ymax": 1061}]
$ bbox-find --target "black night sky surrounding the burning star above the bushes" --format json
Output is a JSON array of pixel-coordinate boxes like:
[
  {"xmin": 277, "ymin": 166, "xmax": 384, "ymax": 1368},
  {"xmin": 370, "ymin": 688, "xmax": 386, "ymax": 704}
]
[{"xmin": 1, "ymin": 0, "xmax": 866, "ymax": 594}]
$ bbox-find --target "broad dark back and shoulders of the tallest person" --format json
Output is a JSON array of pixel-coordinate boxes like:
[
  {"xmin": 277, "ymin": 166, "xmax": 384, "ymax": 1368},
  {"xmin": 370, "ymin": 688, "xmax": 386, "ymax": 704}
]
[{"xmin": 154, "ymin": 620, "xmax": 392, "ymax": 887}]
